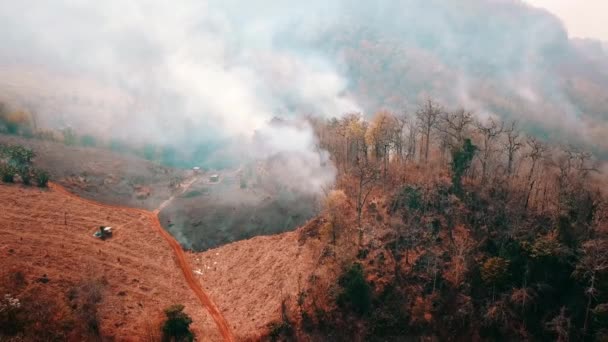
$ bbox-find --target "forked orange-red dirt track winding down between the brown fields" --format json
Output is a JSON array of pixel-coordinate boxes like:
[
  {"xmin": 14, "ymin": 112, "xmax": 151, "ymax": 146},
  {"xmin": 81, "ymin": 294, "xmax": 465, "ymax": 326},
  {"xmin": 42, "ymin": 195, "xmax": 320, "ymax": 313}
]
[{"xmin": 49, "ymin": 182, "xmax": 234, "ymax": 342}]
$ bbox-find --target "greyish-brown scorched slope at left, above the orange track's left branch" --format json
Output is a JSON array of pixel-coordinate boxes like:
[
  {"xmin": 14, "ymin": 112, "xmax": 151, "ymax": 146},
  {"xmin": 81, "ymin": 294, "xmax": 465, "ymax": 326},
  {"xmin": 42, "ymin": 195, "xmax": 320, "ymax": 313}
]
[{"xmin": 0, "ymin": 134, "xmax": 189, "ymax": 209}]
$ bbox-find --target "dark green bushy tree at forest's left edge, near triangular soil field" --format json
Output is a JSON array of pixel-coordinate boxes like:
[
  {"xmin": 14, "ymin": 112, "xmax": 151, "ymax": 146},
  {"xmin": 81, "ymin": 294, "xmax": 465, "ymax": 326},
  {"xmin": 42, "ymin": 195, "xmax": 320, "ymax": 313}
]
[{"xmin": 338, "ymin": 263, "xmax": 372, "ymax": 315}]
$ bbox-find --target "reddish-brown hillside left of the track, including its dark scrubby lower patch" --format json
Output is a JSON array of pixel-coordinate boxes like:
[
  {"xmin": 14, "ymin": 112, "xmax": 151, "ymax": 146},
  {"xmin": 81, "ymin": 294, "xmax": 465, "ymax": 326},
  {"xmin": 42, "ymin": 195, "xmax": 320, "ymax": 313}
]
[{"xmin": 0, "ymin": 185, "xmax": 220, "ymax": 341}]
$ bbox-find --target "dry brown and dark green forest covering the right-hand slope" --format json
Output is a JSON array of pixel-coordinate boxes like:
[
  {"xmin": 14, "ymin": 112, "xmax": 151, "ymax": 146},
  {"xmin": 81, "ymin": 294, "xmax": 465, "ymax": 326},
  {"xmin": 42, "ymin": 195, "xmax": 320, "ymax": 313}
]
[{"xmin": 256, "ymin": 105, "xmax": 608, "ymax": 341}]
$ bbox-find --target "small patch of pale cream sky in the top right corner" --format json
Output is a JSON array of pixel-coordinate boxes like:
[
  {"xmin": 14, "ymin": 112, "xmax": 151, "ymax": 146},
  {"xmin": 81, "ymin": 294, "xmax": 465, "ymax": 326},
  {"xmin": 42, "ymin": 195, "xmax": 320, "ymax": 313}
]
[{"xmin": 526, "ymin": 0, "xmax": 608, "ymax": 41}]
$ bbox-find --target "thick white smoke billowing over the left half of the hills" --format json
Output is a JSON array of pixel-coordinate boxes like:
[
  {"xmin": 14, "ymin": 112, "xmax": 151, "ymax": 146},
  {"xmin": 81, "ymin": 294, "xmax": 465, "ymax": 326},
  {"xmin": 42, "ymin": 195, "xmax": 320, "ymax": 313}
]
[{"xmin": 0, "ymin": 0, "xmax": 360, "ymax": 192}]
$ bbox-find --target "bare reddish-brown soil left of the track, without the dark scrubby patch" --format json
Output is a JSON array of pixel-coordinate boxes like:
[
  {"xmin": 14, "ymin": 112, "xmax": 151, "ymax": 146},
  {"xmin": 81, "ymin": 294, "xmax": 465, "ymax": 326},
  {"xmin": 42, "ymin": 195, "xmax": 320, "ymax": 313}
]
[{"xmin": 0, "ymin": 185, "xmax": 222, "ymax": 341}]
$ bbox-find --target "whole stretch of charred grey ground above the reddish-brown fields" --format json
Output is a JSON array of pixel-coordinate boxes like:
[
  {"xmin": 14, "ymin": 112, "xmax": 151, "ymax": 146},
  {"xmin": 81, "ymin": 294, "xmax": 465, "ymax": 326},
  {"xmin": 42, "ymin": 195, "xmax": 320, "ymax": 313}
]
[{"xmin": 0, "ymin": 134, "xmax": 318, "ymax": 251}]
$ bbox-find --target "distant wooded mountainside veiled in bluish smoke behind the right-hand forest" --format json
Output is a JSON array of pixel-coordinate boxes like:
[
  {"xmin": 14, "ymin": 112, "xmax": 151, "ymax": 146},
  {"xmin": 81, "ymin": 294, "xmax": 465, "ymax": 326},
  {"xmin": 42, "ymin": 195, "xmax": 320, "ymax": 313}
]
[{"xmin": 304, "ymin": 0, "xmax": 608, "ymax": 155}]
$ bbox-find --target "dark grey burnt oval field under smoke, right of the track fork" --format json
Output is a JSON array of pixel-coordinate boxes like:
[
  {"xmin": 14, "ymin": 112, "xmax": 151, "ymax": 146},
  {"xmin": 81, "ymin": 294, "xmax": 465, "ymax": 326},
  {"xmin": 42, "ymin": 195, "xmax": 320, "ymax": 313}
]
[{"xmin": 159, "ymin": 171, "xmax": 318, "ymax": 251}]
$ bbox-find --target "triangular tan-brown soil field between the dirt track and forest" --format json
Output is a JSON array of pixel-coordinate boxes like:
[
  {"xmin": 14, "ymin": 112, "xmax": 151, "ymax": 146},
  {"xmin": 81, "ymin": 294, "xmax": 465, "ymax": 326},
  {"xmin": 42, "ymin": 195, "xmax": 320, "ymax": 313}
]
[{"xmin": 188, "ymin": 220, "xmax": 322, "ymax": 340}]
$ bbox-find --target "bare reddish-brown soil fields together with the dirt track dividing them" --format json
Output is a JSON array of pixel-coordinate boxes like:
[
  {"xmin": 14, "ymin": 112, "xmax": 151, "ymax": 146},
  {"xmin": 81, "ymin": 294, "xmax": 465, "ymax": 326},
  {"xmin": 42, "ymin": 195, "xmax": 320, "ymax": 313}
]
[{"xmin": 0, "ymin": 159, "xmax": 322, "ymax": 341}]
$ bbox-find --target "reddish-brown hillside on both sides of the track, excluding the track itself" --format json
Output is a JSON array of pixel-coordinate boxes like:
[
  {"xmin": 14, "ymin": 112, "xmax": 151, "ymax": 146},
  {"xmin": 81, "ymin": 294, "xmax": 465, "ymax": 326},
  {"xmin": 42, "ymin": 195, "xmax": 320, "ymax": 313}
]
[{"xmin": 0, "ymin": 167, "xmax": 330, "ymax": 341}]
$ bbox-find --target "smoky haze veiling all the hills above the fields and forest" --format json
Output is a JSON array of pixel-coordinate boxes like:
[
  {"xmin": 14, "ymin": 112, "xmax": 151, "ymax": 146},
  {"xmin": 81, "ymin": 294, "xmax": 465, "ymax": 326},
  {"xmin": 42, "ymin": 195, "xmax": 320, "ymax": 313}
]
[{"xmin": 0, "ymin": 0, "xmax": 608, "ymax": 159}]
